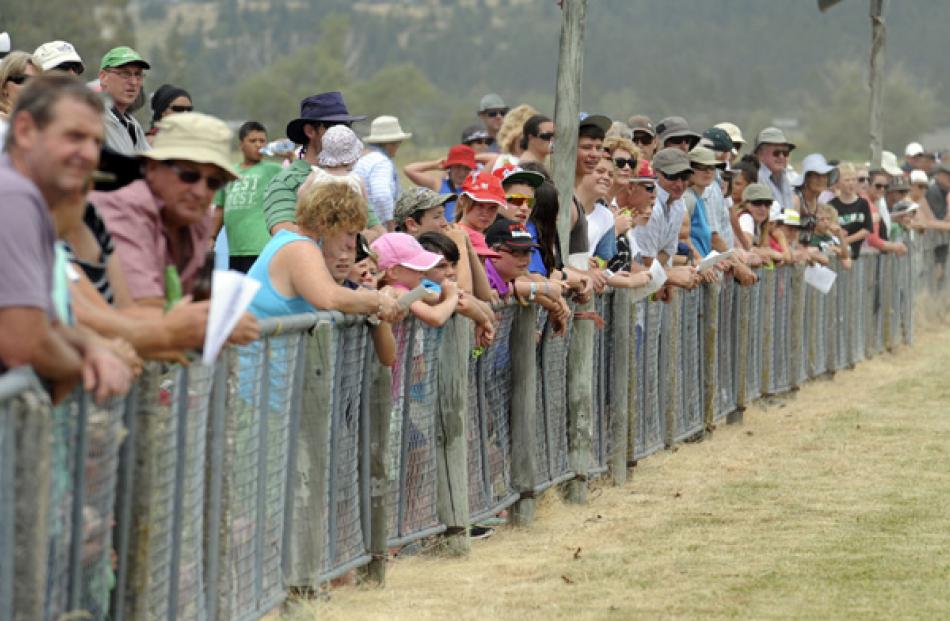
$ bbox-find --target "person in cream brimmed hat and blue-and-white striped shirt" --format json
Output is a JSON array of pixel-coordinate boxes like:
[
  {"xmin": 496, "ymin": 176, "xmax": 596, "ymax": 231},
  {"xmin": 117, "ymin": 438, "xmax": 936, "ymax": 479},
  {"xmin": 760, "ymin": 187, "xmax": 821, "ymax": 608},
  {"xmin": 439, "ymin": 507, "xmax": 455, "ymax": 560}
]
[{"xmin": 353, "ymin": 116, "xmax": 412, "ymax": 231}]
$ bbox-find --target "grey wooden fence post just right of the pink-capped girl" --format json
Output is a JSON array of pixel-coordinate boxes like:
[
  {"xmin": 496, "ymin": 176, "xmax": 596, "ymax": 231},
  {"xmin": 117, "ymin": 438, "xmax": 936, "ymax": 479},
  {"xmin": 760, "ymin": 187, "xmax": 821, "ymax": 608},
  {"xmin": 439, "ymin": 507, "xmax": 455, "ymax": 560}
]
[{"xmin": 436, "ymin": 315, "xmax": 472, "ymax": 556}]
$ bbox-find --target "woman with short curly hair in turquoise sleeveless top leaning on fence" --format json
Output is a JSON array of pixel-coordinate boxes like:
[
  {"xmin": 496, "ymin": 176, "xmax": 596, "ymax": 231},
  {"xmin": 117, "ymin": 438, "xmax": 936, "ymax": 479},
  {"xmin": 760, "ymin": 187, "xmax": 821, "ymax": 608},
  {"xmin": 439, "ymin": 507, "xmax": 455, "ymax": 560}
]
[{"xmin": 248, "ymin": 183, "xmax": 404, "ymax": 322}]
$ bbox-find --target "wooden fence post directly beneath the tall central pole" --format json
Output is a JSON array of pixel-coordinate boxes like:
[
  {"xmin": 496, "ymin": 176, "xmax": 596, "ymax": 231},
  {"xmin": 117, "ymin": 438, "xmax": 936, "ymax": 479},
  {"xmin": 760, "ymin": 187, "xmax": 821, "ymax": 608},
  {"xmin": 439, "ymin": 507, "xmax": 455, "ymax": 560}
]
[{"xmin": 567, "ymin": 299, "xmax": 594, "ymax": 504}]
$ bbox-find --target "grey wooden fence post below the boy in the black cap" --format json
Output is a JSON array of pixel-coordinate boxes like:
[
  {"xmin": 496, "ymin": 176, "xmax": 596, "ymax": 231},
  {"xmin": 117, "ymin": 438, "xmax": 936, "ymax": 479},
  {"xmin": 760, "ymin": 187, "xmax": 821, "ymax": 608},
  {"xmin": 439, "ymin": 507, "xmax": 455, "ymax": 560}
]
[{"xmin": 508, "ymin": 306, "xmax": 538, "ymax": 526}]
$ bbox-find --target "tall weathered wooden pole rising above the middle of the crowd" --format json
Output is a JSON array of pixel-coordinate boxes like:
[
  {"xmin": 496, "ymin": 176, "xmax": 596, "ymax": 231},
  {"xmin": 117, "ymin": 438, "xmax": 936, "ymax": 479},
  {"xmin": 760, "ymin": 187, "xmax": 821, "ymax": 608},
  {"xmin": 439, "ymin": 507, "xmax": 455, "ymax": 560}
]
[{"xmin": 551, "ymin": 0, "xmax": 587, "ymax": 257}]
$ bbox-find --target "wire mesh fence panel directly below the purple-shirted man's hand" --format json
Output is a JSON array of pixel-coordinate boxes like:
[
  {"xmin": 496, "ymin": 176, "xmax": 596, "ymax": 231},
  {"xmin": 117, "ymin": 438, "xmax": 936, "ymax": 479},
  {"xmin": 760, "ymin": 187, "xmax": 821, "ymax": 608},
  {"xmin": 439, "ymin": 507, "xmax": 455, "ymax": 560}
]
[{"xmin": 79, "ymin": 399, "xmax": 125, "ymax": 619}]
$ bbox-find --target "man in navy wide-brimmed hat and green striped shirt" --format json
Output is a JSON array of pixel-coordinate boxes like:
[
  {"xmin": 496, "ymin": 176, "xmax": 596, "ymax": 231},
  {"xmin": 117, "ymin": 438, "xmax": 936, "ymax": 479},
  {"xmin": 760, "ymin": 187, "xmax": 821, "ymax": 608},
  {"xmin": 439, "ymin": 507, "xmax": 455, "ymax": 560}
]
[{"xmin": 264, "ymin": 91, "xmax": 368, "ymax": 235}]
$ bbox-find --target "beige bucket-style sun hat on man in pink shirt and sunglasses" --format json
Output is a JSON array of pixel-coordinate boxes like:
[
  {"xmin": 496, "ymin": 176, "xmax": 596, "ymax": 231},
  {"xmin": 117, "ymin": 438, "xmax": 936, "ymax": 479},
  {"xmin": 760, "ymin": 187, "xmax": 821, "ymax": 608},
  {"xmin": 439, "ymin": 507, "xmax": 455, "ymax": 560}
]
[{"xmin": 139, "ymin": 112, "xmax": 237, "ymax": 180}]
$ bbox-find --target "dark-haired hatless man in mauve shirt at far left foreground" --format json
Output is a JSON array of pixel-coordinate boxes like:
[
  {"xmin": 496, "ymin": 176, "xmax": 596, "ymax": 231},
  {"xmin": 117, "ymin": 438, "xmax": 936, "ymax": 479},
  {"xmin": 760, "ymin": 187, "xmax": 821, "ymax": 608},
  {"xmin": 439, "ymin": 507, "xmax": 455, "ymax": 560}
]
[{"xmin": 0, "ymin": 75, "xmax": 131, "ymax": 402}]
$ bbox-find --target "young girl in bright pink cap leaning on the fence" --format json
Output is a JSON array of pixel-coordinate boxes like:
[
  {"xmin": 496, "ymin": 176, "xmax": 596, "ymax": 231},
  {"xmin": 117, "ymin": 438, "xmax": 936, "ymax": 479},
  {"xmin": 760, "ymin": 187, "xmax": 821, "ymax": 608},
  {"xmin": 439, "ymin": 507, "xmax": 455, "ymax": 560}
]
[{"xmin": 372, "ymin": 233, "xmax": 459, "ymax": 327}]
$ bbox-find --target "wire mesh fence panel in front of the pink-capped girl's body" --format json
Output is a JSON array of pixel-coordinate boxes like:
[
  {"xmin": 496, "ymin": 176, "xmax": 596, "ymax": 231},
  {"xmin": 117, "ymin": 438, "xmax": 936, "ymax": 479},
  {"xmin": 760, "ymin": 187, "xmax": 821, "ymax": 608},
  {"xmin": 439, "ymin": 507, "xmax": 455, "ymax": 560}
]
[{"xmin": 387, "ymin": 319, "xmax": 442, "ymax": 545}]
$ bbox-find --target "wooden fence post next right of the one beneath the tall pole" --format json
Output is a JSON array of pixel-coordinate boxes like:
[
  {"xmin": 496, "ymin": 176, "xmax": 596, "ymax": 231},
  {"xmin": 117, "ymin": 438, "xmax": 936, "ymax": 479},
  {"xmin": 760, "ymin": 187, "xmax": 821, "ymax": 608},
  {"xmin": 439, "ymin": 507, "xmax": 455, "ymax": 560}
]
[{"xmin": 607, "ymin": 289, "xmax": 636, "ymax": 485}]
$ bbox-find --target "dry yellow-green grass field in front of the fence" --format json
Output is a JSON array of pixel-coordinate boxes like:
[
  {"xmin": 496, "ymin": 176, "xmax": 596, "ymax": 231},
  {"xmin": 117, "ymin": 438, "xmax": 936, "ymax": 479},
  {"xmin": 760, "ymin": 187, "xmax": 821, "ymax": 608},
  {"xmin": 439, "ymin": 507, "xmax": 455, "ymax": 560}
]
[{"xmin": 281, "ymin": 306, "xmax": 950, "ymax": 621}]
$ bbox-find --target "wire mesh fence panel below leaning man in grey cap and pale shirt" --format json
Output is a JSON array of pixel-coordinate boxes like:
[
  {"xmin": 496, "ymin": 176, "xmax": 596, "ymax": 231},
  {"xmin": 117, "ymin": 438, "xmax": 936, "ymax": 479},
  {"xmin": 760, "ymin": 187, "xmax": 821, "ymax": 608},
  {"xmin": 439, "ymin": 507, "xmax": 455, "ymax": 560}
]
[{"xmin": 675, "ymin": 288, "xmax": 705, "ymax": 441}]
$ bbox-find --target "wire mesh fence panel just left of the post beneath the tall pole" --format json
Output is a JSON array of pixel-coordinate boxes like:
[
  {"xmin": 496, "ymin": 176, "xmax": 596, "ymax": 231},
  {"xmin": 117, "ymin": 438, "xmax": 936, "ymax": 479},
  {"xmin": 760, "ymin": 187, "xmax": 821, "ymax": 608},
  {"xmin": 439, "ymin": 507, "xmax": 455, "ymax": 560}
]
[{"xmin": 534, "ymin": 310, "xmax": 573, "ymax": 492}]
